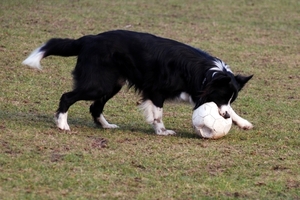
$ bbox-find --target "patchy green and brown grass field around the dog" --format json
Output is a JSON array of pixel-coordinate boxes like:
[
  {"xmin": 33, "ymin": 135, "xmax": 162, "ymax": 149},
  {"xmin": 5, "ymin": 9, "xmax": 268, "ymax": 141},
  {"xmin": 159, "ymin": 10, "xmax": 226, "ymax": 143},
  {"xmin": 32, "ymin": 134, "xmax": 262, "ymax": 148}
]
[{"xmin": 0, "ymin": 0, "xmax": 300, "ymax": 199}]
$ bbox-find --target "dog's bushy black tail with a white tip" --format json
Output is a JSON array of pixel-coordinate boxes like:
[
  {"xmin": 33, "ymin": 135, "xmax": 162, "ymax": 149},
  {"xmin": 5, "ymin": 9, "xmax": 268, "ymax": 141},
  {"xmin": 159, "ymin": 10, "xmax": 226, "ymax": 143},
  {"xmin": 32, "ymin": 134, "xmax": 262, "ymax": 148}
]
[{"xmin": 22, "ymin": 38, "xmax": 81, "ymax": 69}]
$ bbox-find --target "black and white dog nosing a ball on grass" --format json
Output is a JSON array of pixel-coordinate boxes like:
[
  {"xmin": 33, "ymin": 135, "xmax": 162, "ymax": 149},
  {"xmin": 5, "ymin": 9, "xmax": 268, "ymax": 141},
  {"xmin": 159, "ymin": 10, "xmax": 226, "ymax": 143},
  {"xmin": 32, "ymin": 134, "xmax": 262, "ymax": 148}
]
[{"xmin": 23, "ymin": 30, "xmax": 253, "ymax": 135}]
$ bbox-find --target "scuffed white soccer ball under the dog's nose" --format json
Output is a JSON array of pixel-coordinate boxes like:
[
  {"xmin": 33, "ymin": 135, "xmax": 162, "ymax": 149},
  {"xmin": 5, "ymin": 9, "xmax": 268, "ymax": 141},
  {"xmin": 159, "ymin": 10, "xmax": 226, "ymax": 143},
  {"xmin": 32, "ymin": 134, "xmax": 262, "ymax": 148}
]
[{"xmin": 192, "ymin": 102, "xmax": 232, "ymax": 139}]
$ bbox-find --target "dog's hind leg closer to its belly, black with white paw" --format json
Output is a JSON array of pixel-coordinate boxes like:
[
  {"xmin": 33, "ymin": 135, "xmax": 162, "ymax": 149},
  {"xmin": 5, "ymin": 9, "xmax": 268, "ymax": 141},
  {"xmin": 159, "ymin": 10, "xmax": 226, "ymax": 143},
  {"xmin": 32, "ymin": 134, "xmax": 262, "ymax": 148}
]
[{"xmin": 90, "ymin": 86, "xmax": 121, "ymax": 128}]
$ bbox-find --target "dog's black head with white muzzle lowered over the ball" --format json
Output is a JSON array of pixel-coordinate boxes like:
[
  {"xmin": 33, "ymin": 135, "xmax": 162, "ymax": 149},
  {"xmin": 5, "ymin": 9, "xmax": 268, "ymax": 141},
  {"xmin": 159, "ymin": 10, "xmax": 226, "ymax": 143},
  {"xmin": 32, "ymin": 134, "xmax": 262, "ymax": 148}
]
[{"xmin": 195, "ymin": 71, "xmax": 253, "ymax": 118}]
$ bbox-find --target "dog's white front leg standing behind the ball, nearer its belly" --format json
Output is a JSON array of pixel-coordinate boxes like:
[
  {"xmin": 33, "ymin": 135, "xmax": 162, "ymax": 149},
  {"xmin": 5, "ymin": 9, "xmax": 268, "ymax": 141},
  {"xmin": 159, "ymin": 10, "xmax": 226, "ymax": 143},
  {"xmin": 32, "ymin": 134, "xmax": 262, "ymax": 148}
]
[{"xmin": 140, "ymin": 100, "xmax": 176, "ymax": 135}]
